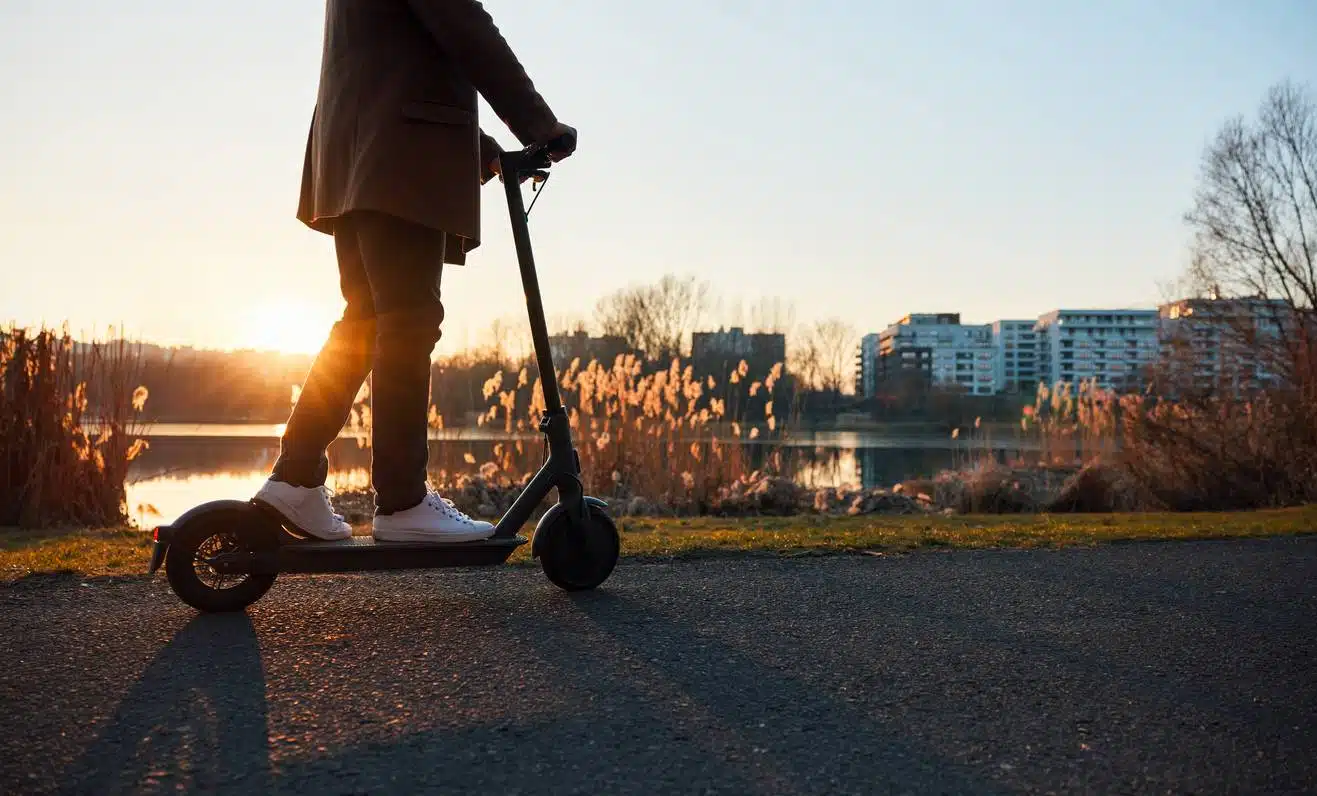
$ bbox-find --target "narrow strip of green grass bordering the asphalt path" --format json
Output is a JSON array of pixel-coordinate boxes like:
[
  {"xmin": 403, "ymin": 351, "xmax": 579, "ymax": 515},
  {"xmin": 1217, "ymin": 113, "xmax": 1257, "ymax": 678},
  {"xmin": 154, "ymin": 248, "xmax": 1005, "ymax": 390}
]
[{"xmin": 0, "ymin": 506, "xmax": 1317, "ymax": 580}]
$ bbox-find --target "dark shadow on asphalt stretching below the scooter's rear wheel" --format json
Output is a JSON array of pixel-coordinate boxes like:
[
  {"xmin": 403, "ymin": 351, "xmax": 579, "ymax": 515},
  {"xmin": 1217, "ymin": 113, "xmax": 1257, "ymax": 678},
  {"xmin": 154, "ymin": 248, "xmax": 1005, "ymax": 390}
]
[{"xmin": 62, "ymin": 614, "xmax": 271, "ymax": 793}]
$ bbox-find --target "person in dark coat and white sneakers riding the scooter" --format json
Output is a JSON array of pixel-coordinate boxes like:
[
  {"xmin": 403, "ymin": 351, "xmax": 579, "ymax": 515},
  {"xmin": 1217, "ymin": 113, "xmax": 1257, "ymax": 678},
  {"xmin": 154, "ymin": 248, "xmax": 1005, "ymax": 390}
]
[{"xmin": 253, "ymin": 0, "xmax": 576, "ymax": 543}]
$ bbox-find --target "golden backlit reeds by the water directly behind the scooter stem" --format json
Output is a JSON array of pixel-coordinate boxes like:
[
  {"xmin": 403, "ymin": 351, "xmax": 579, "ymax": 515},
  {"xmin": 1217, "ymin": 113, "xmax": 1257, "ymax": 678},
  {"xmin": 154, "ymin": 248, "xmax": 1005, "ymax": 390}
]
[{"xmin": 339, "ymin": 355, "xmax": 786, "ymax": 514}]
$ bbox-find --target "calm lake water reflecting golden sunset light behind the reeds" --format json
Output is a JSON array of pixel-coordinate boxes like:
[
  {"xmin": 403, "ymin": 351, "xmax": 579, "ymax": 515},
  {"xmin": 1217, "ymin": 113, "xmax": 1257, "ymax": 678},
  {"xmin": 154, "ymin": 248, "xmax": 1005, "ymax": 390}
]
[{"xmin": 128, "ymin": 423, "xmax": 1029, "ymax": 527}]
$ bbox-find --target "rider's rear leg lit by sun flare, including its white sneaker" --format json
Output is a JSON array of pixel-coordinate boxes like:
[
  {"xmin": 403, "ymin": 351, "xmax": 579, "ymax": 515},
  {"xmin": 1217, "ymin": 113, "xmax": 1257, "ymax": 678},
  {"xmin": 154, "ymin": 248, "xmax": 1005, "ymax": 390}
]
[{"xmin": 255, "ymin": 219, "xmax": 375, "ymax": 539}]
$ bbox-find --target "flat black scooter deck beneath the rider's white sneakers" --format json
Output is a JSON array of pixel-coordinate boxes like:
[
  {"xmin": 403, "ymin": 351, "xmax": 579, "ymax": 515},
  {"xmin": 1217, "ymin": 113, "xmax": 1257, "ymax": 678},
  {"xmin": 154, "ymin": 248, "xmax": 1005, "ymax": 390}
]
[{"xmin": 275, "ymin": 535, "xmax": 527, "ymax": 572}]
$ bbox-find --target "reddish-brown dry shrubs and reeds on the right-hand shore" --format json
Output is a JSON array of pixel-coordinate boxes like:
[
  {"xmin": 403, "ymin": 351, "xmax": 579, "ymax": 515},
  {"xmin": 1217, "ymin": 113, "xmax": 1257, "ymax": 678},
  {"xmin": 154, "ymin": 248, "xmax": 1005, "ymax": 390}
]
[{"xmin": 938, "ymin": 381, "xmax": 1317, "ymax": 511}]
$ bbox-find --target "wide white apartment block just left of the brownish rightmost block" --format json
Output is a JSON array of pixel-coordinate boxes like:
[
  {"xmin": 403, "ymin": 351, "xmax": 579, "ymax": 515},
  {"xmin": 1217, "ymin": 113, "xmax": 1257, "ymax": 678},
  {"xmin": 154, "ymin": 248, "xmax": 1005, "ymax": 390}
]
[{"xmin": 1034, "ymin": 310, "xmax": 1159, "ymax": 390}]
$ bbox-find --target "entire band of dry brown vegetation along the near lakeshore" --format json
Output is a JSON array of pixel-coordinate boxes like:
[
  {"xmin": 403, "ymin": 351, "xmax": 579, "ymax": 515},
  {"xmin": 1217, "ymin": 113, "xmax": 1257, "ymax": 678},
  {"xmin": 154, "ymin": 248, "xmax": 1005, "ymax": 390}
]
[{"xmin": 0, "ymin": 320, "xmax": 1317, "ymax": 527}]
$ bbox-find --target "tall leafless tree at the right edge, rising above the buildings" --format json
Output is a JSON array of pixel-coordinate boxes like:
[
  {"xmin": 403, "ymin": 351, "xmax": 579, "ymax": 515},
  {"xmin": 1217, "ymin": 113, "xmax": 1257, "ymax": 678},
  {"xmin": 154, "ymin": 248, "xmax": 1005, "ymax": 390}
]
[{"xmin": 1187, "ymin": 82, "xmax": 1317, "ymax": 384}]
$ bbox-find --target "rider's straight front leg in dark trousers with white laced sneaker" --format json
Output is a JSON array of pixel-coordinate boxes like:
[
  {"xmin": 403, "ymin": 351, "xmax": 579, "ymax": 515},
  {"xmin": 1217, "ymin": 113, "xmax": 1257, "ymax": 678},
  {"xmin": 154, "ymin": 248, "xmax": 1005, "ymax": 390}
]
[{"xmin": 358, "ymin": 208, "xmax": 494, "ymax": 542}]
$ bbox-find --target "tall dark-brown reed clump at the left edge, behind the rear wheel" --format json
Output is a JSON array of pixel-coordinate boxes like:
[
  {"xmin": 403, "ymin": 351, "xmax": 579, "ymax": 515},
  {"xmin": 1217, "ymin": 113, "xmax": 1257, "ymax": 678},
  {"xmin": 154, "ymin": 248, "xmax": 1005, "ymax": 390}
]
[{"xmin": 0, "ymin": 327, "xmax": 148, "ymax": 527}]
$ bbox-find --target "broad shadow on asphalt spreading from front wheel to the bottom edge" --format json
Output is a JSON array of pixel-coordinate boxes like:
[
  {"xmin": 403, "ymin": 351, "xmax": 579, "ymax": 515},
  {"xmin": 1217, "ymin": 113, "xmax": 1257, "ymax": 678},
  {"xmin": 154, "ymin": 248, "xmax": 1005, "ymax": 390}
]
[{"xmin": 259, "ymin": 592, "xmax": 1000, "ymax": 793}]
